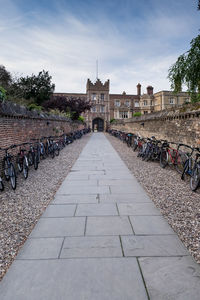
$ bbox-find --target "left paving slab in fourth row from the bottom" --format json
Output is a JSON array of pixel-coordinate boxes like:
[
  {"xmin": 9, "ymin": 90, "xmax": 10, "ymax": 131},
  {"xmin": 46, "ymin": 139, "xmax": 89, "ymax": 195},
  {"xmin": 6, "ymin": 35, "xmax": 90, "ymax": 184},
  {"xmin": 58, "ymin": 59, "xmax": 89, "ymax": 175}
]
[{"xmin": 41, "ymin": 204, "xmax": 76, "ymax": 218}]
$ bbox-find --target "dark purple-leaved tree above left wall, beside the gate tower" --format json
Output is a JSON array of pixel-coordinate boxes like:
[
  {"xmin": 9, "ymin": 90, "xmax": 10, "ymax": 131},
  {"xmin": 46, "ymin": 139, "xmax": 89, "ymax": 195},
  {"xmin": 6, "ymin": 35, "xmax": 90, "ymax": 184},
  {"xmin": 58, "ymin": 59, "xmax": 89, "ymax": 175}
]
[{"xmin": 43, "ymin": 96, "xmax": 92, "ymax": 120}]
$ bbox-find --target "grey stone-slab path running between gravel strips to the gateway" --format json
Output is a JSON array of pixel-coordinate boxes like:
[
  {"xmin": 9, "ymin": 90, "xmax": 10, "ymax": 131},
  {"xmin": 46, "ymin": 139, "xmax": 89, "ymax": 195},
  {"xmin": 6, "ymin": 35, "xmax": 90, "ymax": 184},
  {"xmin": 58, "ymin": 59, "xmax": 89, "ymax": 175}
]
[{"xmin": 0, "ymin": 133, "xmax": 200, "ymax": 300}]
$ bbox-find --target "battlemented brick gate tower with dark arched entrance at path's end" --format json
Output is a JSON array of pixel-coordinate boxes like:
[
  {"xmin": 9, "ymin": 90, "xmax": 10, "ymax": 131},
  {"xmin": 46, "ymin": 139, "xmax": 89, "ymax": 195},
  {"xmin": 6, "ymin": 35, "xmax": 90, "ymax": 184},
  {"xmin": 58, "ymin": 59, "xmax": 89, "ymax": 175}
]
[{"xmin": 85, "ymin": 79, "xmax": 110, "ymax": 131}]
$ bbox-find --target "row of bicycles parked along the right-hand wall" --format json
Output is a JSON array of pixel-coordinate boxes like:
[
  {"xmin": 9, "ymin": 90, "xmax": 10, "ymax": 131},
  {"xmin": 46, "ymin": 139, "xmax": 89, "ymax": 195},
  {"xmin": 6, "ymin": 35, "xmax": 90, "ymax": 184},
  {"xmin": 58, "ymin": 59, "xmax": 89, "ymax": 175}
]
[{"xmin": 108, "ymin": 129, "xmax": 200, "ymax": 191}]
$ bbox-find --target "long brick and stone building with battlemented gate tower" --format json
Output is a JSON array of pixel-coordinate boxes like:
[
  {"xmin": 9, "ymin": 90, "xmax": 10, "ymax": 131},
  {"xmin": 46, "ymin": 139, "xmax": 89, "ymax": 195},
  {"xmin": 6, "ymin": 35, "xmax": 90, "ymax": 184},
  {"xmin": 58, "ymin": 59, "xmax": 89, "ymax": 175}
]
[{"xmin": 54, "ymin": 79, "xmax": 190, "ymax": 131}]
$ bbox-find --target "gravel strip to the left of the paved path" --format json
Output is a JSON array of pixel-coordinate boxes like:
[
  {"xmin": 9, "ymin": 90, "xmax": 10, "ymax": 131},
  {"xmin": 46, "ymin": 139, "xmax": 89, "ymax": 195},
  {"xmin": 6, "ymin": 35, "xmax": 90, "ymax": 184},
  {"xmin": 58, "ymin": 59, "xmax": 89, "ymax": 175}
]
[{"xmin": 0, "ymin": 134, "xmax": 90, "ymax": 280}]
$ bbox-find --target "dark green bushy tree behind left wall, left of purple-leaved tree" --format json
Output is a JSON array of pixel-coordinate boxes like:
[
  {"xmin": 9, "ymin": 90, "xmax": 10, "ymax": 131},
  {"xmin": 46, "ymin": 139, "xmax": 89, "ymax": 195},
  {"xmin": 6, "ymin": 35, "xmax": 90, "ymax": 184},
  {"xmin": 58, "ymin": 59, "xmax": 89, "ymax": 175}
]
[{"xmin": 15, "ymin": 70, "xmax": 55, "ymax": 105}]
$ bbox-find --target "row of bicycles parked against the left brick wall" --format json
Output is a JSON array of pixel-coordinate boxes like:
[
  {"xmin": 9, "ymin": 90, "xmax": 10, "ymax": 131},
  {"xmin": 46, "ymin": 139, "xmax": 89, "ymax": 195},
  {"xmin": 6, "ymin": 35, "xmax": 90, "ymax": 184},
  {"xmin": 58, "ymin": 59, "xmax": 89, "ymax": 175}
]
[{"xmin": 0, "ymin": 128, "xmax": 90, "ymax": 191}]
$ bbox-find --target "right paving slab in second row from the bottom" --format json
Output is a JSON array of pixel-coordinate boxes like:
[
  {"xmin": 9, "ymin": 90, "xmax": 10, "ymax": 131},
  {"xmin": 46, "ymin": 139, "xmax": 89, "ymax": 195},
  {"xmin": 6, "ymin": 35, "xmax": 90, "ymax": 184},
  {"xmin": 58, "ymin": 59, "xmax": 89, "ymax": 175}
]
[{"xmin": 121, "ymin": 235, "xmax": 189, "ymax": 256}]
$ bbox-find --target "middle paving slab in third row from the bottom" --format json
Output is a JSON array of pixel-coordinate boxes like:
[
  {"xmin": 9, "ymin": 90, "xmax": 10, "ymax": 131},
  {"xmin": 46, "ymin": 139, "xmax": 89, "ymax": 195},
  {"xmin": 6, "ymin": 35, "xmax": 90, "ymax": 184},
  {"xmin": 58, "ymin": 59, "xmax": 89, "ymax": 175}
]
[{"xmin": 86, "ymin": 216, "xmax": 133, "ymax": 235}]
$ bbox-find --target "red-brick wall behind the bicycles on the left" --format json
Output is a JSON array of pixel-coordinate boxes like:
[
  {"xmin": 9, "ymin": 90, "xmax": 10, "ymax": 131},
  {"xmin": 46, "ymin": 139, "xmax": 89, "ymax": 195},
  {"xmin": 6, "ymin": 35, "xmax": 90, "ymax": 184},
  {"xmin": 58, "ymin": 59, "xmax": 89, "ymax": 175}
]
[{"xmin": 0, "ymin": 102, "xmax": 84, "ymax": 174}]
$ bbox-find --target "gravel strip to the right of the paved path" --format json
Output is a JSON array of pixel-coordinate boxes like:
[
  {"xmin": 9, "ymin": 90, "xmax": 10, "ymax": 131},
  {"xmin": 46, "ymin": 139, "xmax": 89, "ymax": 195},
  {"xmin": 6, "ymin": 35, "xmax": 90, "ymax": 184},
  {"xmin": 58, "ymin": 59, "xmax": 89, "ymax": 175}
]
[{"xmin": 106, "ymin": 134, "xmax": 200, "ymax": 263}]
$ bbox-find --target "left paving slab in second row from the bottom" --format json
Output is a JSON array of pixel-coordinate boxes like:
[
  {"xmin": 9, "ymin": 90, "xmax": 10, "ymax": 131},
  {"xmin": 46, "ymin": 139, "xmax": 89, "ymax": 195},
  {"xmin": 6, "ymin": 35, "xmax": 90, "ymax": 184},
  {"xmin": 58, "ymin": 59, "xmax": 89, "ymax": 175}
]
[{"xmin": 16, "ymin": 237, "xmax": 64, "ymax": 259}]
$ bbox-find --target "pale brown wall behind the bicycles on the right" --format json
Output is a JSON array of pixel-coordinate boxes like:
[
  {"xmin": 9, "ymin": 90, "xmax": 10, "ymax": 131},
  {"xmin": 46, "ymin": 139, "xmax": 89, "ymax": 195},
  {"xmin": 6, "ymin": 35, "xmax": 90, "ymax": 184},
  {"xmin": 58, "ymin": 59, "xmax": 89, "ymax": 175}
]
[{"xmin": 111, "ymin": 104, "xmax": 200, "ymax": 146}]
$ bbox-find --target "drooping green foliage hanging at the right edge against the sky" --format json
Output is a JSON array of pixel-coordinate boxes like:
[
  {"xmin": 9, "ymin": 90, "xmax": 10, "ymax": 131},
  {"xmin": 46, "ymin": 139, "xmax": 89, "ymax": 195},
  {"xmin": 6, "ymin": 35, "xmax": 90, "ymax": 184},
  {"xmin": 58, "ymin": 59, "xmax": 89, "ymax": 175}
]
[{"xmin": 168, "ymin": 35, "xmax": 200, "ymax": 102}]
